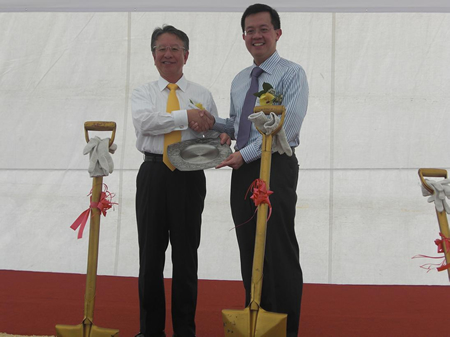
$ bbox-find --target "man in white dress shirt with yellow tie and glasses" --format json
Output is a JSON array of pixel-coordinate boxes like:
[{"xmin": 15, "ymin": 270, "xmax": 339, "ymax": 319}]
[{"xmin": 131, "ymin": 26, "xmax": 227, "ymax": 337}]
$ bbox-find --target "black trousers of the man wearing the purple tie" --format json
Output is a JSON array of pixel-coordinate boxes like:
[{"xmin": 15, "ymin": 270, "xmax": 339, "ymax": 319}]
[{"xmin": 231, "ymin": 153, "xmax": 303, "ymax": 337}]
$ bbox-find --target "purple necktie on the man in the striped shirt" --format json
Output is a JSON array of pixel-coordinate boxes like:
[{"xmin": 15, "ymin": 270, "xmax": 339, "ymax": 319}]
[{"xmin": 237, "ymin": 67, "xmax": 264, "ymax": 150}]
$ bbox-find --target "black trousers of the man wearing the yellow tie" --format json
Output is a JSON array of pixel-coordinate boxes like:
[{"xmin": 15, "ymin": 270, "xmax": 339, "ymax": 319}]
[{"xmin": 136, "ymin": 162, "xmax": 206, "ymax": 337}]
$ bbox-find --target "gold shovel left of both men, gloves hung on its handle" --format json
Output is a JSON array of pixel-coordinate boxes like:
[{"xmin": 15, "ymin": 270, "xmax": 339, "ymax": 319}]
[{"xmin": 56, "ymin": 122, "xmax": 119, "ymax": 337}]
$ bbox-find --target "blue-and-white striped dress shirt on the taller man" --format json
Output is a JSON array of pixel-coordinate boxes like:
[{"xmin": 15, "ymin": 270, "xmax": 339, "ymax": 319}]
[{"xmin": 214, "ymin": 51, "xmax": 309, "ymax": 163}]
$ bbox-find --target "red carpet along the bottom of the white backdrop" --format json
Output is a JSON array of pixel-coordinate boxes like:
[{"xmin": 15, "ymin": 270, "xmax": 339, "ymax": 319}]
[{"xmin": 0, "ymin": 270, "xmax": 450, "ymax": 337}]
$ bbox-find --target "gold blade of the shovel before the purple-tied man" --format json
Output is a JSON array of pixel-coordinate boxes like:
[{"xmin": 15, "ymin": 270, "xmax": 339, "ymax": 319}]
[{"xmin": 222, "ymin": 307, "xmax": 287, "ymax": 337}]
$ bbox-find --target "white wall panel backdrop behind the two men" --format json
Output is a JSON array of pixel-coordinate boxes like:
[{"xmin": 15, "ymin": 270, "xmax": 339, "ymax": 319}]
[{"xmin": 0, "ymin": 12, "xmax": 450, "ymax": 284}]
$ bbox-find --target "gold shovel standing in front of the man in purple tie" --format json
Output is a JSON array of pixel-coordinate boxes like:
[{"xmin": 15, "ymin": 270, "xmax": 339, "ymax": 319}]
[{"xmin": 222, "ymin": 105, "xmax": 287, "ymax": 337}]
